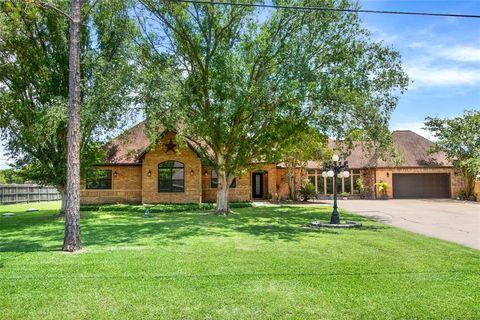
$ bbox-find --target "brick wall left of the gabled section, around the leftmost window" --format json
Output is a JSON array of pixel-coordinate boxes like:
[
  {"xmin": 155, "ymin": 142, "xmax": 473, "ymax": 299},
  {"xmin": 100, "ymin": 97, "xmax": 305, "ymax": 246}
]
[{"xmin": 80, "ymin": 165, "xmax": 142, "ymax": 204}]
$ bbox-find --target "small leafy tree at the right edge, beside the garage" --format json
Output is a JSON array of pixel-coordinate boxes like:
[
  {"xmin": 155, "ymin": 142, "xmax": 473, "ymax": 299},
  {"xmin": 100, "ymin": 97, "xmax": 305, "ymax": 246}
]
[{"xmin": 425, "ymin": 110, "xmax": 480, "ymax": 199}]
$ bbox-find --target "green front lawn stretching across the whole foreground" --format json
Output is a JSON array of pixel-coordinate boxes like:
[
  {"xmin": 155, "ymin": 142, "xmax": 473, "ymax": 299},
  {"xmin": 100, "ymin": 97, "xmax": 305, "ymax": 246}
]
[{"xmin": 0, "ymin": 203, "xmax": 480, "ymax": 319}]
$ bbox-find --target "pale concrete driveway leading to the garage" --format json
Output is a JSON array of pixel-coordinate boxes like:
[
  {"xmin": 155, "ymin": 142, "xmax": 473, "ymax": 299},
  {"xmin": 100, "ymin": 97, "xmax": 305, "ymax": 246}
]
[{"xmin": 338, "ymin": 200, "xmax": 480, "ymax": 250}]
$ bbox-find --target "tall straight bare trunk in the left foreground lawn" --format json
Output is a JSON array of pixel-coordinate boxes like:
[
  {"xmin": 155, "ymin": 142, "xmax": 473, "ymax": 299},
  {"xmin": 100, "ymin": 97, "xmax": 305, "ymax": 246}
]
[{"xmin": 63, "ymin": 0, "xmax": 82, "ymax": 252}]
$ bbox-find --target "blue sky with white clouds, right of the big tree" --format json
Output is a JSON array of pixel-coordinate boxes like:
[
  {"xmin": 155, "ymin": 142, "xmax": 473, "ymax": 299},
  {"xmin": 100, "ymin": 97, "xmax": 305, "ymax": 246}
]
[{"xmin": 0, "ymin": 0, "xmax": 480, "ymax": 168}]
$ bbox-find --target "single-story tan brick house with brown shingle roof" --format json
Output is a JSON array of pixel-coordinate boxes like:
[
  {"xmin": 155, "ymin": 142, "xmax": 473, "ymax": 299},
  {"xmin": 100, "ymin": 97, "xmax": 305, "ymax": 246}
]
[{"xmin": 81, "ymin": 123, "xmax": 463, "ymax": 203}]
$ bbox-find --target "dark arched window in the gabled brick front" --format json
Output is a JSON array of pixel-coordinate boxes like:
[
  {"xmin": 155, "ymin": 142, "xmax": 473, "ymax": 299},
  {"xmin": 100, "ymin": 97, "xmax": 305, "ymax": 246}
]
[{"xmin": 158, "ymin": 161, "xmax": 185, "ymax": 192}]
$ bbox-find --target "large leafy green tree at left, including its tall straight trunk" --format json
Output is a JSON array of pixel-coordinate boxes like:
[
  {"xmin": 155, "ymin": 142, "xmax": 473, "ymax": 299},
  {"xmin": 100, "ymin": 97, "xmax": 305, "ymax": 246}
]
[{"xmin": 0, "ymin": 0, "xmax": 134, "ymax": 251}]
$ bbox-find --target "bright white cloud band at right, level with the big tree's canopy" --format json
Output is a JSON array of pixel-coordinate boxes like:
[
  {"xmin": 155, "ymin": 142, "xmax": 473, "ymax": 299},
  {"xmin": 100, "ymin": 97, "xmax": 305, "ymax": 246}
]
[{"xmin": 406, "ymin": 65, "xmax": 480, "ymax": 86}]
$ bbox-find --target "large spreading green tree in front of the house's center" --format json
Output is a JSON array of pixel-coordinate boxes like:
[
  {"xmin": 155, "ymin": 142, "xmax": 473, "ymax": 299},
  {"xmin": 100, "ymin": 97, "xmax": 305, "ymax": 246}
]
[{"xmin": 136, "ymin": 0, "xmax": 408, "ymax": 213}]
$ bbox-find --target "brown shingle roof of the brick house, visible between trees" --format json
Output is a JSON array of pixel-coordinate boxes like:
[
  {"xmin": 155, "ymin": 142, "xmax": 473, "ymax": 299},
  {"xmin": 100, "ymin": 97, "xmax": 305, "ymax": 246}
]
[{"xmin": 105, "ymin": 122, "xmax": 451, "ymax": 168}]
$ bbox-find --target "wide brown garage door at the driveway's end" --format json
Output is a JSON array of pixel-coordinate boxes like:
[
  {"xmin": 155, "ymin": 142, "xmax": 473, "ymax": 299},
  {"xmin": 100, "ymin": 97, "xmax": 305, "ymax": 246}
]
[{"xmin": 393, "ymin": 173, "xmax": 450, "ymax": 199}]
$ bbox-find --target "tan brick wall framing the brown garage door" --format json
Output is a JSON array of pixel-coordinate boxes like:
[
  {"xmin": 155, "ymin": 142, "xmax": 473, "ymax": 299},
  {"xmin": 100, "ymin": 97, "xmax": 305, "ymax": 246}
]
[{"xmin": 375, "ymin": 168, "xmax": 464, "ymax": 198}]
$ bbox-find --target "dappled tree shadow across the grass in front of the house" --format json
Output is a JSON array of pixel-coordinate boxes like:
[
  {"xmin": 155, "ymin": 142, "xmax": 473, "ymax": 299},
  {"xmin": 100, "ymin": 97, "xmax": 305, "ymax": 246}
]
[{"xmin": 0, "ymin": 206, "xmax": 382, "ymax": 252}]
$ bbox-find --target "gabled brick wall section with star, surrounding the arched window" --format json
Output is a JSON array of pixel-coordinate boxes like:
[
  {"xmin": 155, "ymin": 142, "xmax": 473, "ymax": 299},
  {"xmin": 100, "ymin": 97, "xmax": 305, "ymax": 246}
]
[{"xmin": 142, "ymin": 132, "xmax": 202, "ymax": 203}]
